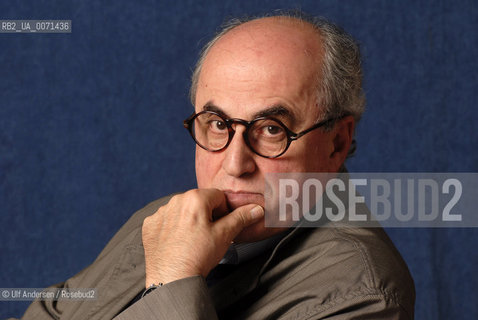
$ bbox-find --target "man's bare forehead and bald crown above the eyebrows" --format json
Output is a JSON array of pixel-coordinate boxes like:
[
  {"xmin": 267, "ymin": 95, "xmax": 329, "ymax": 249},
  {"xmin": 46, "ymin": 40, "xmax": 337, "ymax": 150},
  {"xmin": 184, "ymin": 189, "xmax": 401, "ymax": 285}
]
[{"xmin": 196, "ymin": 18, "xmax": 322, "ymax": 122}]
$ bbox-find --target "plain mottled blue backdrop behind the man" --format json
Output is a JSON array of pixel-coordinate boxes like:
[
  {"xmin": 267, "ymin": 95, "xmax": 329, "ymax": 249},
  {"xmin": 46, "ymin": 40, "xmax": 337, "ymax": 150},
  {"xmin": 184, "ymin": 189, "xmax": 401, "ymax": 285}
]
[{"xmin": 0, "ymin": 0, "xmax": 478, "ymax": 319}]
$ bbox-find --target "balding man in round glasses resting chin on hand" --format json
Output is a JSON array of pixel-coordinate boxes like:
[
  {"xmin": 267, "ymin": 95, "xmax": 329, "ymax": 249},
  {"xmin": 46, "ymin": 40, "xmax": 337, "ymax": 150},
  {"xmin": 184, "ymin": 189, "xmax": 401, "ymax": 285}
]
[{"xmin": 15, "ymin": 11, "xmax": 415, "ymax": 319}]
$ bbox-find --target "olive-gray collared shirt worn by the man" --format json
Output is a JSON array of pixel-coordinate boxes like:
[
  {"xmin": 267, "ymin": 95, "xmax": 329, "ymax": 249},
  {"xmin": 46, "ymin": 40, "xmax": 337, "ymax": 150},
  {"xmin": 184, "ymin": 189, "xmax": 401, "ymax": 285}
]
[{"xmin": 14, "ymin": 197, "xmax": 415, "ymax": 320}]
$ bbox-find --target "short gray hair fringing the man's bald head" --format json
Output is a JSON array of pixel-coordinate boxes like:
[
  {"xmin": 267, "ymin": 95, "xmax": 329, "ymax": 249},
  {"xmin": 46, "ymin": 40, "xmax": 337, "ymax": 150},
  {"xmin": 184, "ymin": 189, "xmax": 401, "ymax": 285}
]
[{"xmin": 189, "ymin": 11, "xmax": 365, "ymax": 155}]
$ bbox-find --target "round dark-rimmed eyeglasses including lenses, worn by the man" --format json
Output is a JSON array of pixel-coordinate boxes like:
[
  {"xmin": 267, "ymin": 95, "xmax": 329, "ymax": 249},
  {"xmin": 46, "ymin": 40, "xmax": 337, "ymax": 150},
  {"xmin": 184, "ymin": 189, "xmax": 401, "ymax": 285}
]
[{"xmin": 184, "ymin": 111, "xmax": 338, "ymax": 158}]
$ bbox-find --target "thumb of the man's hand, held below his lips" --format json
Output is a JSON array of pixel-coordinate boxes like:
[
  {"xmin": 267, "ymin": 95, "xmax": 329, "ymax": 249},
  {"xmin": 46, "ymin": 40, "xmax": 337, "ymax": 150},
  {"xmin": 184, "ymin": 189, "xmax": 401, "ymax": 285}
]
[{"xmin": 215, "ymin": 204, "xmax": 264, "ymax": 242}]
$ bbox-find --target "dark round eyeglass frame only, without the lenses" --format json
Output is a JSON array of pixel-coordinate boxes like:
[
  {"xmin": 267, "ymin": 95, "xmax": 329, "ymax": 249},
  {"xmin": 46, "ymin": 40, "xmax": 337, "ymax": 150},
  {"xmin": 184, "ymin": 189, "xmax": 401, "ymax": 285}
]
[{"xmin": 183, "ymin": 110, "xmax": 343, "ymax": 159}]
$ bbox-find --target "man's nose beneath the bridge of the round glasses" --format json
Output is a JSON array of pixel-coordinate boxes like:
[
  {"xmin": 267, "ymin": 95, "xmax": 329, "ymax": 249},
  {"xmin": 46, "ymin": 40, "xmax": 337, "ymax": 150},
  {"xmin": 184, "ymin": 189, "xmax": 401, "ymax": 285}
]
[{"xmin": 222, "ymin": 125, "xmax": 256, "ymax": 178}]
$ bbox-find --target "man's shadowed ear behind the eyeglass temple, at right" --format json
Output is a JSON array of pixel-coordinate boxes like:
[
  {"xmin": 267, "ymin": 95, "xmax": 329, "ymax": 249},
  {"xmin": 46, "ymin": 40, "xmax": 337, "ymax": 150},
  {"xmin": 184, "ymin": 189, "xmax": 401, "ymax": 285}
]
[{"xmin": 330, "ymin": 116, "xmax": 355, "ymax": 170}]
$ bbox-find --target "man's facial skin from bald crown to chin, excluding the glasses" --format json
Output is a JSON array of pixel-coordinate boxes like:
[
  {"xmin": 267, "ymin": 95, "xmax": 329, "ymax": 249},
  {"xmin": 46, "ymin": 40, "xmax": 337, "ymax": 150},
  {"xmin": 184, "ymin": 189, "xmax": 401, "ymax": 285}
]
[{"xmin": 195, "ymin": 18, "xmax": 353, "ymax": 241}]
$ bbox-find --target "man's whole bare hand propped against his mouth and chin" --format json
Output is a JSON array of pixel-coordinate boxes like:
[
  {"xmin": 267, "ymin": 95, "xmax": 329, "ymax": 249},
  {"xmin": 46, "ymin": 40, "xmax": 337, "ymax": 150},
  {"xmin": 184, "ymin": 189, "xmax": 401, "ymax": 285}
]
[{"xmin": 143, "ymin": 189, "xmax": 264, "ymax": 287}]
